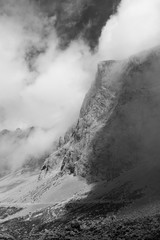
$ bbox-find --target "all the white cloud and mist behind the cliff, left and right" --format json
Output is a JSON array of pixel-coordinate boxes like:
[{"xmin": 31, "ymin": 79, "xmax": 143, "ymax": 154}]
[{"xmin": 0, "ymin": 0, "xmax": 160, "ymax": 171}]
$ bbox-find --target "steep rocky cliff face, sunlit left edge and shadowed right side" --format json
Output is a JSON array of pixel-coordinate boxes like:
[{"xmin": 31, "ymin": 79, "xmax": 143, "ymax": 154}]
[{"xmin": 42, "ymin": 49, "xmax": 160, "ymax": 181}]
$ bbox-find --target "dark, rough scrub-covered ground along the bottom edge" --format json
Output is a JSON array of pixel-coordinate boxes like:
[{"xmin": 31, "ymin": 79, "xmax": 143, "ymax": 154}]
[{"xmin": 0, "ymin": 203, "xmax": 160, "ymax": 240}]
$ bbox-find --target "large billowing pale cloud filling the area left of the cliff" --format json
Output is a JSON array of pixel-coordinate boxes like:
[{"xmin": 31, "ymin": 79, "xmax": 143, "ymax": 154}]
[{"xmin": 0, "ymin": 0, "xmax": 96, "ymax": 170}]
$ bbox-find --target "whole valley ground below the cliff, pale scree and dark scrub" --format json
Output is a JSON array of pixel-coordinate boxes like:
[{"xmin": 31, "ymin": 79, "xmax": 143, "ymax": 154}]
[{"xmin": 0, "ymin": 170, "xmax": 160, "ymax": 240}]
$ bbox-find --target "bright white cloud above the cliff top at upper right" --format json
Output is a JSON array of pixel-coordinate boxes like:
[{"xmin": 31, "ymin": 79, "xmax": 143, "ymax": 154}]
[{"xmin": 99, "ymin": 0, "xmax": 160, "ymax": 59}]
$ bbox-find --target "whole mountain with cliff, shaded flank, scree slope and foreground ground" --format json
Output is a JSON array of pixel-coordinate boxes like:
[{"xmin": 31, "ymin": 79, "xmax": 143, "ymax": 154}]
[{"xmin": 0, "ymin": 47, "xmax": 160, "ymax": 240}]
